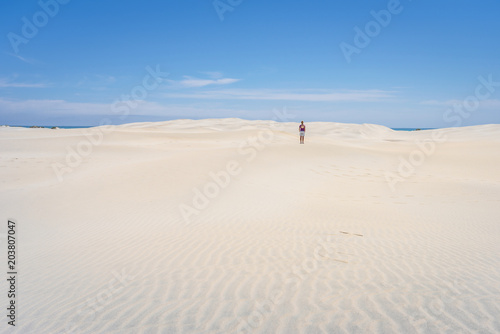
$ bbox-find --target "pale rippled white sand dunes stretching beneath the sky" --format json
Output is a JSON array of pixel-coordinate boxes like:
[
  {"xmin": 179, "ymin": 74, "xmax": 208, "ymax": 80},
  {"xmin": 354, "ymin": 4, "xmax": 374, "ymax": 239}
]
[{"xmin": 0, "ymin": 119, "xmax": 500, "ymax": 334}]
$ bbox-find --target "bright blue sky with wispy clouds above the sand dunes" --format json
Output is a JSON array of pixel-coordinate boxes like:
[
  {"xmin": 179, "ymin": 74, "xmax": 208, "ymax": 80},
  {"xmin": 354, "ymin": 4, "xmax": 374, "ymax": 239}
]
[{"xmin": 0, "ymin": 0, "xmax": 500, "ymax": 127}]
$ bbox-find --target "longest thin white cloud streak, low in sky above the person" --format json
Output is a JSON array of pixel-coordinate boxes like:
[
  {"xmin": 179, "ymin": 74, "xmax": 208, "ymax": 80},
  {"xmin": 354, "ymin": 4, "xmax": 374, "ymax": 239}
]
[{"xmin": 162, "ymin": 89, "xmax": 395, "ymax": 102}]
